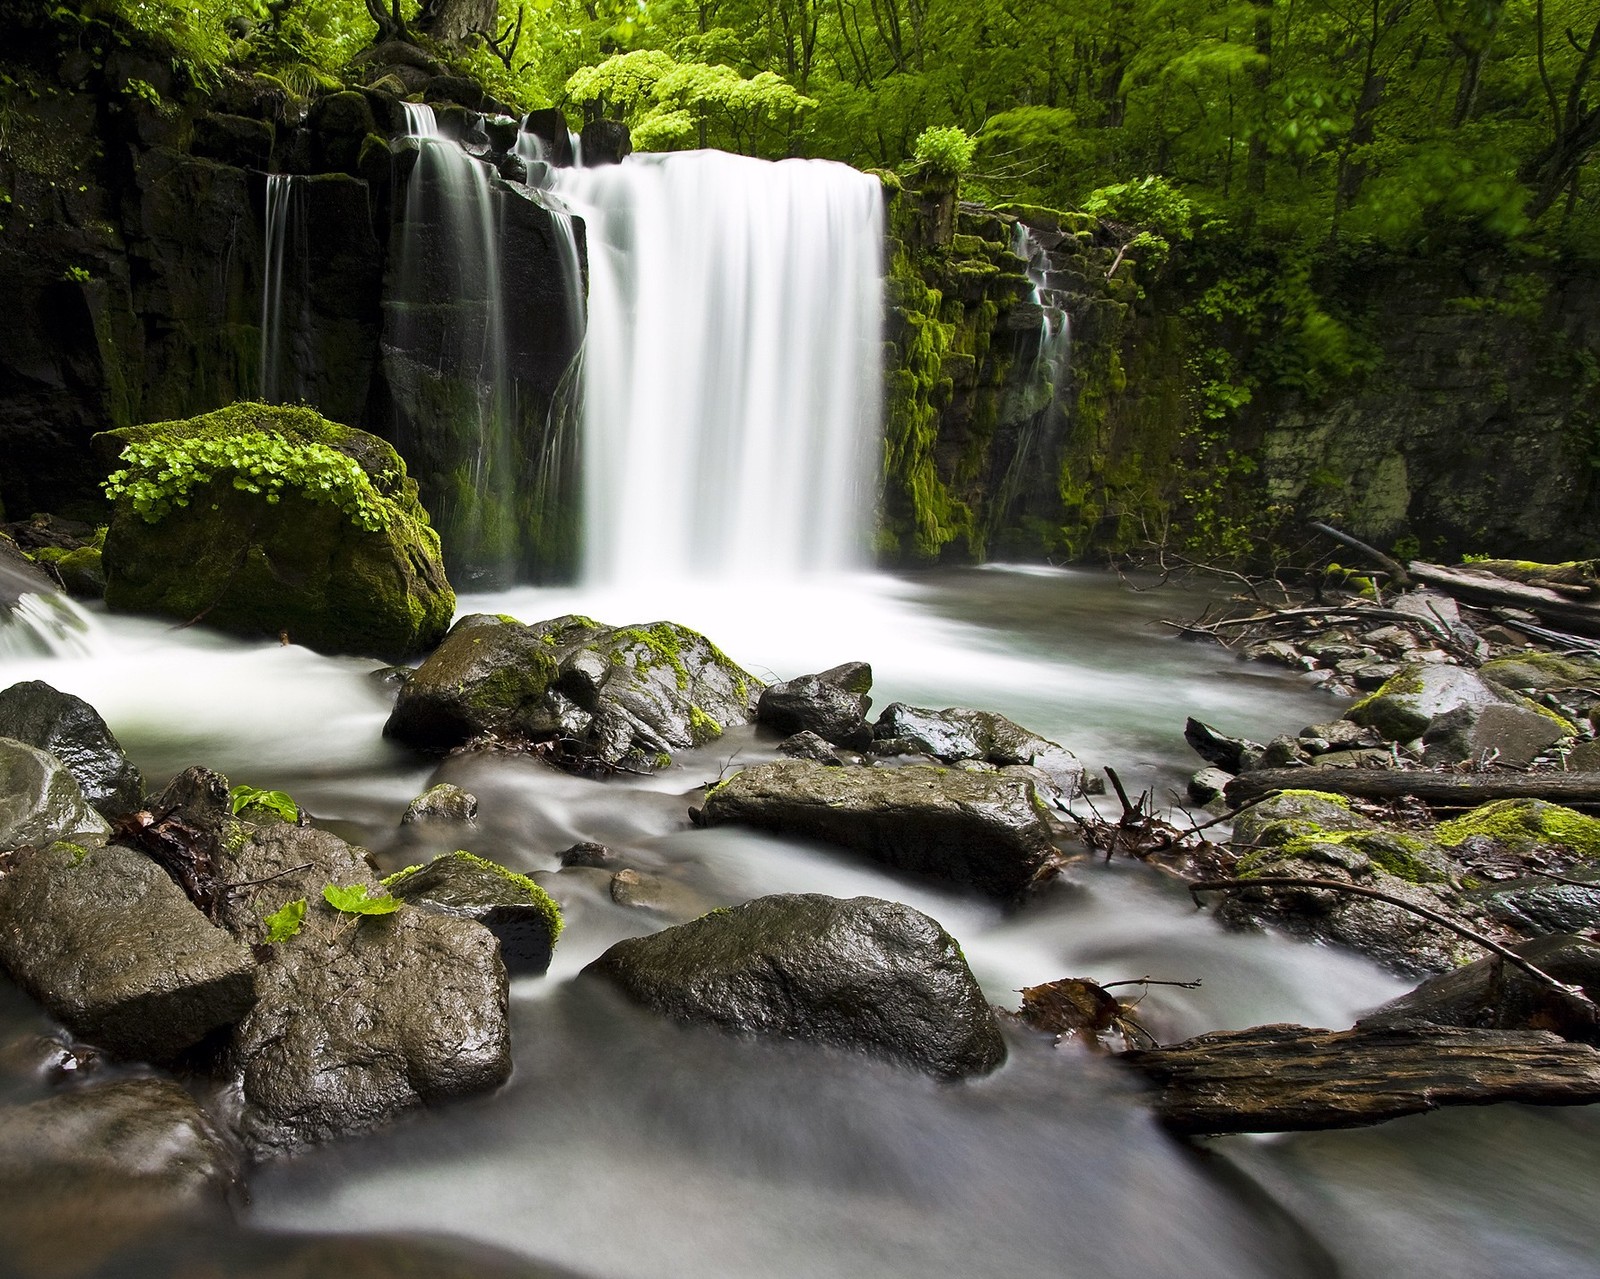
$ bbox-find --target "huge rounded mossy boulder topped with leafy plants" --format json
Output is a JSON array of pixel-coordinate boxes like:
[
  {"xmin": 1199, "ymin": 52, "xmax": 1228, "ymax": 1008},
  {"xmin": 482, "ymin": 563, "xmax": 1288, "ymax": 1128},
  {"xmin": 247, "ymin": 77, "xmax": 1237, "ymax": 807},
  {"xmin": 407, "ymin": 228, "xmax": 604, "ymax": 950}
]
[{"xmin": 96, "ymin": 403, "xmax": 456, "ymax": 660}]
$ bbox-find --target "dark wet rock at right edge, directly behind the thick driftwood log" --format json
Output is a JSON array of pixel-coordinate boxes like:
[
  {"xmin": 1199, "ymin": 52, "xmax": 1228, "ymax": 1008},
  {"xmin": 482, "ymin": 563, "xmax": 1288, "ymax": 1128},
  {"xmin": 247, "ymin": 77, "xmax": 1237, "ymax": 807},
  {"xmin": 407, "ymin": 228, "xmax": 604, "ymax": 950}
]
[{"xmin": 1357, "ymin": 933, "xmax": 1600, "ymax": 1044}]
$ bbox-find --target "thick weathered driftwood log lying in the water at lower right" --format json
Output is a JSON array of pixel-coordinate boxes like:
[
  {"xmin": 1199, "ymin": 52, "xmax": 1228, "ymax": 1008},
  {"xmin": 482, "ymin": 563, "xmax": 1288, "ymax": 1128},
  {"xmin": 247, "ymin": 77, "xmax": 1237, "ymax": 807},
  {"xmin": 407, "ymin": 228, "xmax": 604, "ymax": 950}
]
[{"xmin": 1118, "ymin": 1026, "xmax": 1600, "ymax": 1133}]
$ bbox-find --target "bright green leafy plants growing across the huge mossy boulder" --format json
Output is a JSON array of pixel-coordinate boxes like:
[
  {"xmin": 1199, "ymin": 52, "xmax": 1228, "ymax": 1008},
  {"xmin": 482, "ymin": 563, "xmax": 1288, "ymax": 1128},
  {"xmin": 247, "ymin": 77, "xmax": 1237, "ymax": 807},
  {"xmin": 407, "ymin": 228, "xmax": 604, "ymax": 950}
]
[{"xmin": 102, "ymin": 431, "xmax": 390, "ymax": 531}]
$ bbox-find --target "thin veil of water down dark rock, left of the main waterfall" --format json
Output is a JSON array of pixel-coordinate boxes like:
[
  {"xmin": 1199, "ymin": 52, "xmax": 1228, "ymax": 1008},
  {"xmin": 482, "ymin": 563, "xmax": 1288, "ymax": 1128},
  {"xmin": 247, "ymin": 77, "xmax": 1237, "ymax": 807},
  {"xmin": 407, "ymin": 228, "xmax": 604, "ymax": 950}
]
[{"xmin": 384, "ymin": 102, "xmax": 520, "ymax": 576}]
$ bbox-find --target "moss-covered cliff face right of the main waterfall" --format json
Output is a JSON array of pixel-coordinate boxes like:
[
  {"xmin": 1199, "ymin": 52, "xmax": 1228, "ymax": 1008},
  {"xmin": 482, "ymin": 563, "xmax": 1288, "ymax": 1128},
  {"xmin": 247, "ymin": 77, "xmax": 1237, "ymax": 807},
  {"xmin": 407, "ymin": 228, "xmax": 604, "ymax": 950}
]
[{"xmin": 883, "ymin": 180, "xmax": 1600, "ymax": 562}]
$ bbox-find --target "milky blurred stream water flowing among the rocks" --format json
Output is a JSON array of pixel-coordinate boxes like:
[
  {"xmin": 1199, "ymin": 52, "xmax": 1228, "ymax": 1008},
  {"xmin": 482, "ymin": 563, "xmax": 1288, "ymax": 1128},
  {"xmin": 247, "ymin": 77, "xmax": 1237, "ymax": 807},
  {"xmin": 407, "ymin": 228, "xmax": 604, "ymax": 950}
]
[{"xmin": 9, "ymin": 567, "xmax": 1600, "ymax": 1279}]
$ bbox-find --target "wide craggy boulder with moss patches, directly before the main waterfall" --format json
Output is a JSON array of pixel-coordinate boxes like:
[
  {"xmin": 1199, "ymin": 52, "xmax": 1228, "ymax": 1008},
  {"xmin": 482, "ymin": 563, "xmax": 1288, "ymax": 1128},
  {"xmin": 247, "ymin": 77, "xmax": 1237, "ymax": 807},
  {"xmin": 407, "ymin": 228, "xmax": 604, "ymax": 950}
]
[{"xmin": 384, "ymin": 613, "xmax": 763, "ymax": 770}]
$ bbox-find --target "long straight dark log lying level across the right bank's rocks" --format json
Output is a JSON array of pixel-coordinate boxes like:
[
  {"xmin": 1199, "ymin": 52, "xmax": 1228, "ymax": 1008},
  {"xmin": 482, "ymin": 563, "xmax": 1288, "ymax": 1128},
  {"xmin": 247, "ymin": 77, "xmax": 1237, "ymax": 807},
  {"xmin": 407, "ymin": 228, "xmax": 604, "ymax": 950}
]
[{"xmin": 1224, "ymin": 768, "xmax": 1600, "ymax": 808}]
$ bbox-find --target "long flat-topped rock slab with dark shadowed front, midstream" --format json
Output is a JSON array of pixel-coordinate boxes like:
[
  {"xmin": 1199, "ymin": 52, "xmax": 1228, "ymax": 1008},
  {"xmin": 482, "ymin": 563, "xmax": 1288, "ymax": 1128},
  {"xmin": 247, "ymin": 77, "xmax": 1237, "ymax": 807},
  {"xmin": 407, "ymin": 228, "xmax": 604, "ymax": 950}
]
[{"xmin": 698, "ymin": 760, "xmax": 1054, "ymax": 898}]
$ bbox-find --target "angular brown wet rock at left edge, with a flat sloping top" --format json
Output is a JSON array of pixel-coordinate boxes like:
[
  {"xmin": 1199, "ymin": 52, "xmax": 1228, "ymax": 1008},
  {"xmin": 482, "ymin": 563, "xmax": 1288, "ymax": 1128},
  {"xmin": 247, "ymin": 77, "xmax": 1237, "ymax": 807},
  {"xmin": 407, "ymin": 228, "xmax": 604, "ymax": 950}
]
[{"xmin": 0, "ymin": 842, "xmax": 256, "ymax": 1061}]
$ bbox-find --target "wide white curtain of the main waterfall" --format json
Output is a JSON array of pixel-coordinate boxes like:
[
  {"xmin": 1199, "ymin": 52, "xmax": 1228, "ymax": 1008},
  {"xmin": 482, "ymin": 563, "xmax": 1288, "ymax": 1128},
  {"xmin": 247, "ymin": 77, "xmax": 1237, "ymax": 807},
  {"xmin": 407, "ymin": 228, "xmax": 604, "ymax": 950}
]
[{"xmin": 554, "ymin": 150, "xmax": 883, "ymax": 583}]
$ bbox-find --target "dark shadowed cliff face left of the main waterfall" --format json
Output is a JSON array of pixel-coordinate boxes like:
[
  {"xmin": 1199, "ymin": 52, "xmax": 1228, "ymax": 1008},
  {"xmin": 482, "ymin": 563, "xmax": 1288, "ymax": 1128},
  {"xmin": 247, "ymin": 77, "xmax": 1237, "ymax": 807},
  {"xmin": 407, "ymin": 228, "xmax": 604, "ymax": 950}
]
[{"xmin": 0, "ymin": 30, "xmax": 582, "ymax": 568}]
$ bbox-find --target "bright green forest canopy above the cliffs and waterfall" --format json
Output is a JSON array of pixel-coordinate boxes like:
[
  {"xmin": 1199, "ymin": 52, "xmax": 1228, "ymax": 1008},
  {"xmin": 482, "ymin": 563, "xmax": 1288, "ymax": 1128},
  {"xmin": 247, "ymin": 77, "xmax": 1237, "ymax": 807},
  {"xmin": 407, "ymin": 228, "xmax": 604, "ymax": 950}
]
[{"xmin": 5, "ymin": 0, "xmax": 1600, "ymax": 256}]
